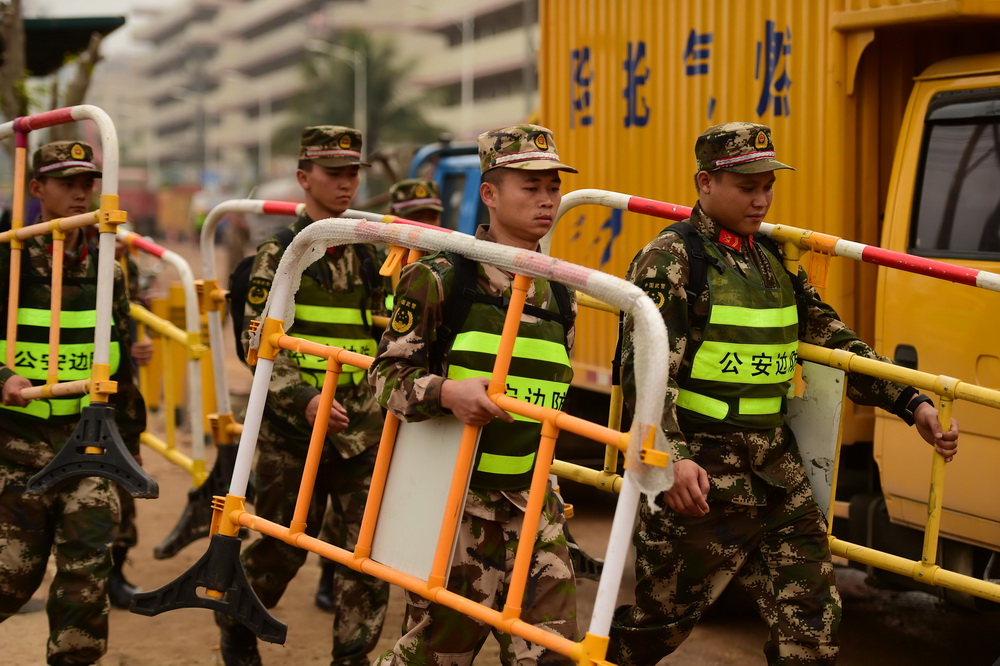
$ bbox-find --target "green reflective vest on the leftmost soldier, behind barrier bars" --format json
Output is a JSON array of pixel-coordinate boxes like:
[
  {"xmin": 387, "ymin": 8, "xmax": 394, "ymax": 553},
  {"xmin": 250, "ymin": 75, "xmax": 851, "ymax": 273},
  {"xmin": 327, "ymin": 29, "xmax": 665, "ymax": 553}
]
[{"xmin": 0, "ymin": 278, "xmax": 121, "ymax": 423}]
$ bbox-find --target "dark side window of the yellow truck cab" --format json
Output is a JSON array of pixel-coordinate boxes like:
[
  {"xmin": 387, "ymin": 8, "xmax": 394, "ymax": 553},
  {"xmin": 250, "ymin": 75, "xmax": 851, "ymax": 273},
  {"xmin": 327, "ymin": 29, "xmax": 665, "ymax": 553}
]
[{"xmin": 910, "ymin": 89, "xmax": 1000, "ymax": 260}]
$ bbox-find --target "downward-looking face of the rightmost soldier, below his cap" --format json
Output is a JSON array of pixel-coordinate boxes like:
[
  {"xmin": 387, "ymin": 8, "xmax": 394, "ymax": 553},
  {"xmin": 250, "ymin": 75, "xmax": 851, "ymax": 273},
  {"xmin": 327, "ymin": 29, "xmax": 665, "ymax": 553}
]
[{"xmin": 697, "ymin": 171, "xmax": 774, "ymax": 236}]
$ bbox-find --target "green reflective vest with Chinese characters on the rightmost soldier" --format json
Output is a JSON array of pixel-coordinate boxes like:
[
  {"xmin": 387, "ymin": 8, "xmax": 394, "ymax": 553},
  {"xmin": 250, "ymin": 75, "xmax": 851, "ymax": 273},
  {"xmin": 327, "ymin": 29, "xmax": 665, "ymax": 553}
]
[{"xmin": 677, "ymin": 236, "xmax": 799, "ymax": 428}]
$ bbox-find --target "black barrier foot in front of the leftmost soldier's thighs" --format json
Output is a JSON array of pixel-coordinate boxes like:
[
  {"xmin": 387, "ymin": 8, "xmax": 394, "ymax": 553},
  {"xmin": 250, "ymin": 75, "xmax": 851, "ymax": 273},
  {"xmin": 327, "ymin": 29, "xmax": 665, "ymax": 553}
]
[{"xmin": 28, "ymin": 402, "xmax": 160, "ymax": 499}]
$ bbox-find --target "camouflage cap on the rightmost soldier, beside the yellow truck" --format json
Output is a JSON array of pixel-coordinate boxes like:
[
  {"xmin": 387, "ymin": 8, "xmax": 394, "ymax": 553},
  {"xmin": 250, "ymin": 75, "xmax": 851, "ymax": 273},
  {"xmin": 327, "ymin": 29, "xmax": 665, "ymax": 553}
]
[{"xmin": 694, "ymin": 123, "xmax": 794, "ymax": 173}]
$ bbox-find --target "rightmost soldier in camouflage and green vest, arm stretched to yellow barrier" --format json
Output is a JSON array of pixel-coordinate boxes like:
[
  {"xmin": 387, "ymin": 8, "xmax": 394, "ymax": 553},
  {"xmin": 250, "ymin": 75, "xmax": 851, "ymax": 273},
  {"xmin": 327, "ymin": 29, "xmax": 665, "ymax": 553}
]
[{"xmin": 608, "ymin": 123, "xmax": 958, "ymax": 666}]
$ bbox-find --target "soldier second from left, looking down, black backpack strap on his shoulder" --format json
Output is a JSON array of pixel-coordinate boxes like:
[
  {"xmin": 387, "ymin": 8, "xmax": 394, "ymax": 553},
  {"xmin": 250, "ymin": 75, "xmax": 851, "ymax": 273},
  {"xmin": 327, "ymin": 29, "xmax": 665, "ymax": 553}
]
[{"xmin": 216, "ymin": 125, "xmax": 390, "ymax": 666}]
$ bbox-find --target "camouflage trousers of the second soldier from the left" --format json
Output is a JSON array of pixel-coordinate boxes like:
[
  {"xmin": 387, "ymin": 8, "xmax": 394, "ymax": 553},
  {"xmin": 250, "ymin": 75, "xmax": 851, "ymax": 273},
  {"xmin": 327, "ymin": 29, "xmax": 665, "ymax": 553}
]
[{"xmin": 217, "ymin": 440, "xmax": 389, "ymax": 666}]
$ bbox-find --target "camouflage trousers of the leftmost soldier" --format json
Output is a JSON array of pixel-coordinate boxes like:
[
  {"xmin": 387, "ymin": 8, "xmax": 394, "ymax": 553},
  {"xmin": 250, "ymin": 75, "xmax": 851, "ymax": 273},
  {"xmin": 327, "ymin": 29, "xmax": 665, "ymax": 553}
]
[{"xmin": 0, "ymin": 421, "xmax": 121, "ymax": 663}]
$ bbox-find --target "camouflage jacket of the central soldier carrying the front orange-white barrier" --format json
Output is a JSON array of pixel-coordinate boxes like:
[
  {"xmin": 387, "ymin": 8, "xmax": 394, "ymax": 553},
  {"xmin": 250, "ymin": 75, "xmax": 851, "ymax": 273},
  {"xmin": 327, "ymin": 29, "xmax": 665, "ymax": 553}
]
[{"xmin": 368, "ymin": 226, "xmax": 576, "ymax": 521}]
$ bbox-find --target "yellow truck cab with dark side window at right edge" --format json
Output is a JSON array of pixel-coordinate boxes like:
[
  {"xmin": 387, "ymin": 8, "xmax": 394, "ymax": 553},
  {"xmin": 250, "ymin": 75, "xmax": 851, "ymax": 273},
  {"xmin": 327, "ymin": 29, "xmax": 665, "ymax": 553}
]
[{"xmin": 868, "ymin": 54, "xmax": 1000, "ymax": 600}]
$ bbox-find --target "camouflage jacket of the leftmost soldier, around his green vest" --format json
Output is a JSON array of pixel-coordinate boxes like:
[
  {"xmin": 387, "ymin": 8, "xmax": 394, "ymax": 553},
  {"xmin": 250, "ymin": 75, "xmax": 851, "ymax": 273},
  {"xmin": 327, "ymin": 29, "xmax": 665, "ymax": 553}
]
[{"xmin": 0, "ymin": 228, "xmax": 146, "ymax": 469}]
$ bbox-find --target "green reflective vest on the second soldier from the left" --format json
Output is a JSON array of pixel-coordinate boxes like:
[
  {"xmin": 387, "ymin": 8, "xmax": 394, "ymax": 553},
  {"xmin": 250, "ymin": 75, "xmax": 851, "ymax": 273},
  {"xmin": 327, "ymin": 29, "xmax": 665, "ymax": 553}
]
[{"xmin": 288, "ymin": 254, "xmax": 378, "ymax": 388}]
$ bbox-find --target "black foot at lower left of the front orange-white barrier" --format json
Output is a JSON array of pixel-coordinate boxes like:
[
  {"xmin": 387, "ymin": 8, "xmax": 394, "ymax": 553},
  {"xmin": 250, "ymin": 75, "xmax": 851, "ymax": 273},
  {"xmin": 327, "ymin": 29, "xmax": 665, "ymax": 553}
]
[{"xmin": 130, "ymin": 534, "xmax": 288, "ymax": 645}]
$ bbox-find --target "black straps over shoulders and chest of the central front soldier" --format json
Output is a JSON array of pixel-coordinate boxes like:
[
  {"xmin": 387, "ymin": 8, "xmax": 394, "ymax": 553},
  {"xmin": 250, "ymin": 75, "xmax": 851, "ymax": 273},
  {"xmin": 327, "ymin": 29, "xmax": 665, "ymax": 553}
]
[{"xmin": 430, "ymin": 252, "xmax": 573, "ymax": 373}]
